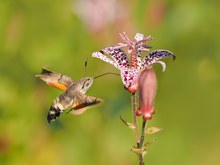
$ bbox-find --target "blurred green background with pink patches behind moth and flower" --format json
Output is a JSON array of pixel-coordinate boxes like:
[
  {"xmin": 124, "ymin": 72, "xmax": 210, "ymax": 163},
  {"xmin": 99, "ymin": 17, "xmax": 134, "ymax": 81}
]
[{"xmin": 0, "ymin": 0, "xmax": 220, "ymax": 165}]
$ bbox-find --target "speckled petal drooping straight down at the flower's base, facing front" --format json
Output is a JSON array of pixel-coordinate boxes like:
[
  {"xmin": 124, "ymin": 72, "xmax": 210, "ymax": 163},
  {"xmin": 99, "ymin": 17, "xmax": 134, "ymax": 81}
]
[{"xmin": 121, "ymin": 68, "xmax": 140, "ymax": 88}]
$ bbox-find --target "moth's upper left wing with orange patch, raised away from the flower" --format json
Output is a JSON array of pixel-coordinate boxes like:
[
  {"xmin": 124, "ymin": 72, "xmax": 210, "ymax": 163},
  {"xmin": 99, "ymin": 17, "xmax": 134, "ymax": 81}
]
[{"xmin": 36, "ymin": 68, "xmax": 74, "ymax": 91}]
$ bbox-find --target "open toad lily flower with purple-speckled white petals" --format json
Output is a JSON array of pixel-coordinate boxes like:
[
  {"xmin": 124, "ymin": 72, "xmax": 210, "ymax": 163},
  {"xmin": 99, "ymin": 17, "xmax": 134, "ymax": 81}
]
[{"xmin": 92, "ymin": 33, "xmax": 175, "ymax": 93}]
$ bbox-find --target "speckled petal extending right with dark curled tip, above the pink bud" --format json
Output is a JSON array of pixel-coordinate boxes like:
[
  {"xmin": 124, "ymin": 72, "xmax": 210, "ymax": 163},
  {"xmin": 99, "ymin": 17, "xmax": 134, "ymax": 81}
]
[{"xmin": 142, "ymin": 50, "xmax": 176, "ymax": 69}]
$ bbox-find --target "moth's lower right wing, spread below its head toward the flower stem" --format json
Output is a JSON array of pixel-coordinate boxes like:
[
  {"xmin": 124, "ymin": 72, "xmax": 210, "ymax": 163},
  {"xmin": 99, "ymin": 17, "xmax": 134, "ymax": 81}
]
[{"xmin": 70, "ymin": 92, "xmax": 103, "ymax": 115}]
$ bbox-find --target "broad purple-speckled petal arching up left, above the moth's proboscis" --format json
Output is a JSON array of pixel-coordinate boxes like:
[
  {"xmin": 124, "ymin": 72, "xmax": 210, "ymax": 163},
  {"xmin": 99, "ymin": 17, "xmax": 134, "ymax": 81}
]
[{"xmin": 102, "ymin": 46, "xmax": 129, "ymax": 69}]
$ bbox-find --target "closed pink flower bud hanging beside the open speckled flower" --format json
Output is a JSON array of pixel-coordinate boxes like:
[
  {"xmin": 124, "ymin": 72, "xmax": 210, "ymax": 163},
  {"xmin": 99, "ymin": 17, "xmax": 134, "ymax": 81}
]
[{"xmin": 138, "ymin": 67, "xmax": 157, "ymax": 120}]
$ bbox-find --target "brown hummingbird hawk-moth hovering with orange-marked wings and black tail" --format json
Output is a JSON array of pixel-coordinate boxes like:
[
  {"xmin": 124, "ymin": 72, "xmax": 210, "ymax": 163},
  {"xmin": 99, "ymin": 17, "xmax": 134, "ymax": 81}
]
[{"xmin": 36, "ymin": 68, "xmax": 103, "ymax": 123}]
